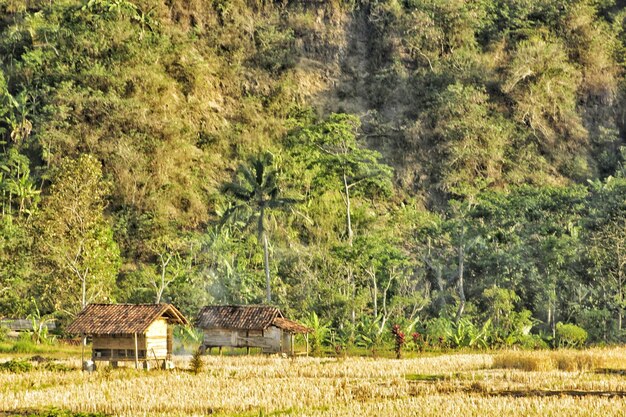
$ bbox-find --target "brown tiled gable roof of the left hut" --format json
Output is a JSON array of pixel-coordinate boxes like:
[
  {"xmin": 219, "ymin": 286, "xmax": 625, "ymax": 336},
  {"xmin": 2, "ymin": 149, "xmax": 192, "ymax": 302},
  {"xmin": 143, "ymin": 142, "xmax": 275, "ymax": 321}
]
[{"xmin": 66, "ymin": 304, "xmax": 189, "ymax": 334}]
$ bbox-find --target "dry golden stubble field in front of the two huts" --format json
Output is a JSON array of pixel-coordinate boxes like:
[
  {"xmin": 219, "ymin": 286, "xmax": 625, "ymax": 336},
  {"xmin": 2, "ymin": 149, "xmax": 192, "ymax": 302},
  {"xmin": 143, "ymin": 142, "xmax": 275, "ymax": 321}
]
[{"xmin": 0, "ymin": 349, "xmax": 626, "ymax": 417}]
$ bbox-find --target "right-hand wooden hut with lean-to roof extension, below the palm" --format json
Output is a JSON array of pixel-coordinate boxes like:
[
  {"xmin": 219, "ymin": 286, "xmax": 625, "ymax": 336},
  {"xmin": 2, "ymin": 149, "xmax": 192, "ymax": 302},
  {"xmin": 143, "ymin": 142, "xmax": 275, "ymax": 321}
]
[{"xmin": 196, "ymin": 305, "xmax": 310, "ymax": 355}]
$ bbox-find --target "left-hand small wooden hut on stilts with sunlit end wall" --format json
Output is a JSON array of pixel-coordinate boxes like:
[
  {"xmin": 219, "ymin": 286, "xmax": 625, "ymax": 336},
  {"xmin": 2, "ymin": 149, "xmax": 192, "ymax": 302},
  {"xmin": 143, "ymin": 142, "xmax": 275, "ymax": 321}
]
[{"xmin": 66, "ymin": 304, "xmax": 189, "ymax": 368}]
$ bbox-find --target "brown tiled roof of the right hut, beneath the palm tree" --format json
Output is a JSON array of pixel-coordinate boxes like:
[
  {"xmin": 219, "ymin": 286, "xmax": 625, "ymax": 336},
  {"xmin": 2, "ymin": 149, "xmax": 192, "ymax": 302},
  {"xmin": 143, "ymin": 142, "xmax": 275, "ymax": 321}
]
[{"xmin": 196, "ymin": 305, "xmax": 310, "ymax": 333}]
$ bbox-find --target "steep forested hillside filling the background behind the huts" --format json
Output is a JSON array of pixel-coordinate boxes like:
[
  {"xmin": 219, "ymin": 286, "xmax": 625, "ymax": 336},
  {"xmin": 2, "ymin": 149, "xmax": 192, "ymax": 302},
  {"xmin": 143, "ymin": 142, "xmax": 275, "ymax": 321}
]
[{"xmin": 0, "ymin": 0, "xmax": 626, "ymax": 345}]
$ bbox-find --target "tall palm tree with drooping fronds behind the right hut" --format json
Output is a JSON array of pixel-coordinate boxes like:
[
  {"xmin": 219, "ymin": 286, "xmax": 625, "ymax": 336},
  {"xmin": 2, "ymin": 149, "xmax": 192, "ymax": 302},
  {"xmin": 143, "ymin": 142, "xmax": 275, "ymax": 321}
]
[{"xmin": 222, "ymin": 152, "xmax": 299, "ymax": 303}]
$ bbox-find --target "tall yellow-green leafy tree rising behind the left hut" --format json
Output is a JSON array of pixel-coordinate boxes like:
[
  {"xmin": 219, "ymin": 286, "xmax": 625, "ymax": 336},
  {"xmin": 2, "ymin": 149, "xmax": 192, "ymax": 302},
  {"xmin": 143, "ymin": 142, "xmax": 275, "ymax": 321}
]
[{"xmin": 35, "ymin": 154, "xmax": 119, "ymax": 315}]
